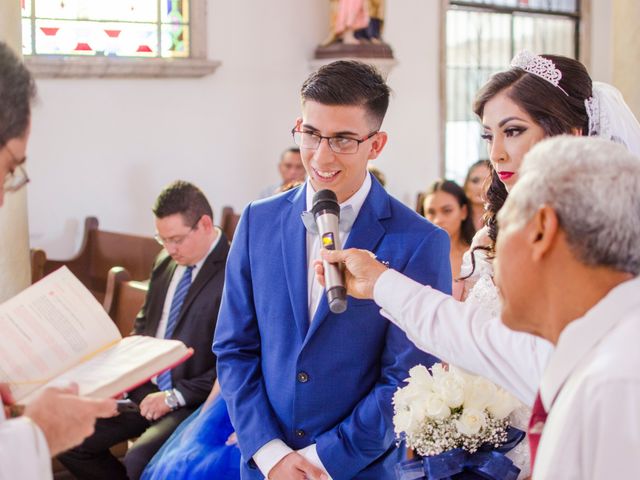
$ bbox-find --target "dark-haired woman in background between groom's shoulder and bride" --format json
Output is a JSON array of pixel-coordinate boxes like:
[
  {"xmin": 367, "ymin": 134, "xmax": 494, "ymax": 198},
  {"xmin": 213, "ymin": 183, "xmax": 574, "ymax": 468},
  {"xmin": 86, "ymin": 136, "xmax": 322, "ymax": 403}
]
[{"xmin": 423, "ymin": 180, "xmax": 476, "ymax": 296}]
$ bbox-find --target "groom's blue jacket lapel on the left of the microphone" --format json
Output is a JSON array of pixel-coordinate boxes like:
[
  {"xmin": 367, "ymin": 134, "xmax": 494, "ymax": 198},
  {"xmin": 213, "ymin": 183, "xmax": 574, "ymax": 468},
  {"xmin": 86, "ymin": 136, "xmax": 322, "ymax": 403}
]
[{"xmin": 281, "ymin": 186, "xmax": 309, "ymax": 341}]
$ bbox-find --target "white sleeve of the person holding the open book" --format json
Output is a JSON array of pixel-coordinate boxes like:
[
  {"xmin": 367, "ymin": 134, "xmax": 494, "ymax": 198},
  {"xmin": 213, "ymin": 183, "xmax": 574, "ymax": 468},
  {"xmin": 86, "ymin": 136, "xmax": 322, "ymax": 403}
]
[{"xmin": 0, "ymin": 417, "xmax": 53, "ymax": 480}]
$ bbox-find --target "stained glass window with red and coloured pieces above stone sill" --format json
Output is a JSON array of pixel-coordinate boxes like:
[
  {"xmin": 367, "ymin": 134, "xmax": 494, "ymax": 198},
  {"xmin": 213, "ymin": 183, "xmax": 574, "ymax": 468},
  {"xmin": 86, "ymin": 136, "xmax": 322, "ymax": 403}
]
[{"xmin": 20, "ymin": 0, "xmax": 191, "ymax": 58}]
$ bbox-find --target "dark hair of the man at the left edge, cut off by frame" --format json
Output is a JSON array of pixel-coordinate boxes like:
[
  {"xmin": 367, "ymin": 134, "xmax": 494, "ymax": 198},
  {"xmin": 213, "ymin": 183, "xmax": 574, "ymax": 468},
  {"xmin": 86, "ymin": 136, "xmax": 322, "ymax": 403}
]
[{"xmin": 0, "ymin": 42, "xmax": 36, "ymax": 147}]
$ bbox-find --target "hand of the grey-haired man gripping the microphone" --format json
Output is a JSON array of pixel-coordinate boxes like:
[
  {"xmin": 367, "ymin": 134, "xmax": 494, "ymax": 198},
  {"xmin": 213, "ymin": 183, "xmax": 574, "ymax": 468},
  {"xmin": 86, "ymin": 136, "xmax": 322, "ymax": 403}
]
[{"xmin": 314, "ymin": 248, "xmax": 387, "ymax": 299}]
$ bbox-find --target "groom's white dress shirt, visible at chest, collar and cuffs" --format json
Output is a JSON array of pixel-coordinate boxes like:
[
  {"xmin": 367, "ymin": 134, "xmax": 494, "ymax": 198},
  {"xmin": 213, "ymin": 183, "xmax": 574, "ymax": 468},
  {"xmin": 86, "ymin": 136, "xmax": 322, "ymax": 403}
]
[{"xmin": 253, "ymin": 173, "xmax": 371, "ymax": 480}]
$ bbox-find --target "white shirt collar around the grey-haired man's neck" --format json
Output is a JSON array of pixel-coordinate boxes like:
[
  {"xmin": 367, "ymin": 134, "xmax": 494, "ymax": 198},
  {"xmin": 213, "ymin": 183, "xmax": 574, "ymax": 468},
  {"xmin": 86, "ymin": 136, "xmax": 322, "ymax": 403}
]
[{"xmin": 540, "ymin": 277, "xmax": 640, "ymax": 412}]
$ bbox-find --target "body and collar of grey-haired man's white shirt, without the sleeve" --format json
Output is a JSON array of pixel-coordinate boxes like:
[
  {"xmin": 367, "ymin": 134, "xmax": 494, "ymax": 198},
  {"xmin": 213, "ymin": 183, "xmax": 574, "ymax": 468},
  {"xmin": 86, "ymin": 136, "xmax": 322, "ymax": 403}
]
[{"xmin": 533, "ymin": 278, "xmax": 640, "ymax": 480}]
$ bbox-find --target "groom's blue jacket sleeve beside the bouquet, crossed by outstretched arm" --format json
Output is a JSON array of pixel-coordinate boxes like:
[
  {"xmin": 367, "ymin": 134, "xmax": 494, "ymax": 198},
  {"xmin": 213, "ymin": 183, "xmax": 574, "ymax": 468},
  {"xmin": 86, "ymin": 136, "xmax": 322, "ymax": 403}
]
[{"xmin": 316, "ymin": 229, "xmax": 451, "ymax": 478}]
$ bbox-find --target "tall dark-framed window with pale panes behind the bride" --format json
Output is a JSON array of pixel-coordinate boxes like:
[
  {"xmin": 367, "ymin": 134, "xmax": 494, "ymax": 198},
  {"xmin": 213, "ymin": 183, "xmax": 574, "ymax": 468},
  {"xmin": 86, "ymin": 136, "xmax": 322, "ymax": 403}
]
[{"xmin": 445, "ymin": 0, "xmax": 581, "ymax": 180}]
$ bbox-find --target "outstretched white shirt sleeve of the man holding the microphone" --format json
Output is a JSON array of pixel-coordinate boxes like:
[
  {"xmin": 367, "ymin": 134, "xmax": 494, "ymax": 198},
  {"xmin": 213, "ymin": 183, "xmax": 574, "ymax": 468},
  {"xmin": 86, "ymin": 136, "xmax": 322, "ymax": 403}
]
[{"xmin": 374, "ymin": 270, "xmax": 553, "ymax": 406}]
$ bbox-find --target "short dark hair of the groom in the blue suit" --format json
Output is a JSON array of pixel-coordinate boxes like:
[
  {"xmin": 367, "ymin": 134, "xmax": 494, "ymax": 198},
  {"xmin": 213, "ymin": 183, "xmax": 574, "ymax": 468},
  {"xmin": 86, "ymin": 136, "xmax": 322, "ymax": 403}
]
[{"xmin": 300, "ymin": 60, "xmax": 391, "ymax": 128}]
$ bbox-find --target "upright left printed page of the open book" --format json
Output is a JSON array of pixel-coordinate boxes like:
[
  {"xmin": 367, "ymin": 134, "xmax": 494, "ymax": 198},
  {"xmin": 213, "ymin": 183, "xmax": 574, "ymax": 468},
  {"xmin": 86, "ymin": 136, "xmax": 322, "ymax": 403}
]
[{"xmin": 0, "ymin": 267, "xmax": 121, "ymax": 401}]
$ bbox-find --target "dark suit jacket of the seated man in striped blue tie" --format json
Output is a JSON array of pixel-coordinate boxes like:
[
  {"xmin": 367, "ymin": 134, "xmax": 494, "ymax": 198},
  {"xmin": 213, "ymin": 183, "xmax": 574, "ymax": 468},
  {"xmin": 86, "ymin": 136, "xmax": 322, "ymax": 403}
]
[{"xmin": 129, "ymin": 234, "xmax": 229, "ymax": 407}]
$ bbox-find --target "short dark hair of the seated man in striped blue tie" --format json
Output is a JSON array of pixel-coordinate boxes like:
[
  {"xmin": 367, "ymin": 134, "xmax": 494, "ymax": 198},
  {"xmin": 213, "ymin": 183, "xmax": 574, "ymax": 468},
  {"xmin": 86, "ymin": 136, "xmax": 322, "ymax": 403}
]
[{"xmin": 152, "ymin": 180, "xmax": 213, "ymax": 227}]
